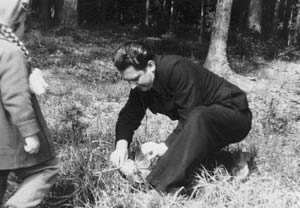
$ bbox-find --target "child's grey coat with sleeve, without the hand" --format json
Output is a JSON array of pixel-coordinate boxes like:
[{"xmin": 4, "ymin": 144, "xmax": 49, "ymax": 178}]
[{"xmin": 0, "ymin": 35, "xmax": 55, "ymax": 170}]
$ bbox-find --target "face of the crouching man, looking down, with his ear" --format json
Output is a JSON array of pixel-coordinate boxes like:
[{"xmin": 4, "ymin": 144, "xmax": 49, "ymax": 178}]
[{"xmin": 121, "ymin": 60, "xmax": 155, "ymax": 91}]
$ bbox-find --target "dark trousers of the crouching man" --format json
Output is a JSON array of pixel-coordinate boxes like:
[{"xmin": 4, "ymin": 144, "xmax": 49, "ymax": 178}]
[{"xmin": 146, "ymin": 105, "xmax": 252, "ymax": 193}]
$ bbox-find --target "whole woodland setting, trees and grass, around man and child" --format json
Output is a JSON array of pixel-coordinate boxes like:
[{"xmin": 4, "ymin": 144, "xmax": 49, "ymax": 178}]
[{"xmin": 4, "ymin": 0, "xmax": 300, "ymax": 208}]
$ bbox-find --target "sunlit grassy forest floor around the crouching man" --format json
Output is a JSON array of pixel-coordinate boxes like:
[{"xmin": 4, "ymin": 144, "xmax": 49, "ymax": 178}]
[{"xmin": 5, "ymin": 26, "xmax": 300, "ymax": 208}]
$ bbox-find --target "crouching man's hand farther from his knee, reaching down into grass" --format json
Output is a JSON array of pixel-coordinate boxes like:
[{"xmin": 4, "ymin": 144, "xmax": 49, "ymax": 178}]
[{"xmin": 110, "ymin": 140, "xmax": 128, "ymax": 167}]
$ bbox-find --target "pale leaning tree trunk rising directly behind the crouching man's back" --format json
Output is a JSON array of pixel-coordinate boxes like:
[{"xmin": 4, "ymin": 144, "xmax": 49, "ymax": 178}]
[{"xmin": 204, "ymin": 0, "xmax": 233, "ymax": 76}]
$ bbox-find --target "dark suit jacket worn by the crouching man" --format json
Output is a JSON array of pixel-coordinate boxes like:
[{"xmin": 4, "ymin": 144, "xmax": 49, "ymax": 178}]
[{"xmin": 116, "ymin": 55, "xmax": 249, "ymax": 143}]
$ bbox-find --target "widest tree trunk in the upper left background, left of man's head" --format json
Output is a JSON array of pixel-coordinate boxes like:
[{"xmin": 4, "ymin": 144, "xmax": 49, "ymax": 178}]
[{"xmin": 61, "ymin": 0, "xmax": 78, "ymax": 27}]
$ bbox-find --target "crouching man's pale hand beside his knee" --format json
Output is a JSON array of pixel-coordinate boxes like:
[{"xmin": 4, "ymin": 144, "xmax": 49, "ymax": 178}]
[{"xmin": 141, "ymin": 142, "xmax": 168, "ymax": 160}]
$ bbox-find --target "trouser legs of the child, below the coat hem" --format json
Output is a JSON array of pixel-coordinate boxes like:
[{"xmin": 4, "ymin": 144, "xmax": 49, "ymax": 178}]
[{"xmin": 0, "ymin": 158, "xmax": 59, "ymax": 208}]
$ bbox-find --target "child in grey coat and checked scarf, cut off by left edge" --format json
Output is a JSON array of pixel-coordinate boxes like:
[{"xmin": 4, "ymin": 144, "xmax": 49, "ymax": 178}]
[{"xmin": 0, "ymin": 0, "xmax": 59, "ymax": 208}]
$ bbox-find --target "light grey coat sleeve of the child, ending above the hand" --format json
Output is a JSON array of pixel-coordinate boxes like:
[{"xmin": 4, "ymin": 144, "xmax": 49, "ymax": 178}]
[{"xmin": 0, "ymin": 47, "xmax": 39, "ymax": 137}]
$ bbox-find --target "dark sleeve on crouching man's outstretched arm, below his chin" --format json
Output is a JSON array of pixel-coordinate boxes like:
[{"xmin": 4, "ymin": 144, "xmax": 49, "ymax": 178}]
[{"xmin": 116, "ymin": 89, "xmax": 146, "ymax": 144}]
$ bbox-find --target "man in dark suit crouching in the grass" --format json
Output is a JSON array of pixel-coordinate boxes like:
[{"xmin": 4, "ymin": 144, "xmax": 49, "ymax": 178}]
[{"xmin": 111, "ymin": 42, "xmax": 252, "ymax": 193}]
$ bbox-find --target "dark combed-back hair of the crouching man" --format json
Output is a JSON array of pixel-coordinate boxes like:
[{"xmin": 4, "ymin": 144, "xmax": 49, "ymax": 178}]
[{"xmin": 113, "ymin": 41, "xmax": 154, "ymax": 72}]
